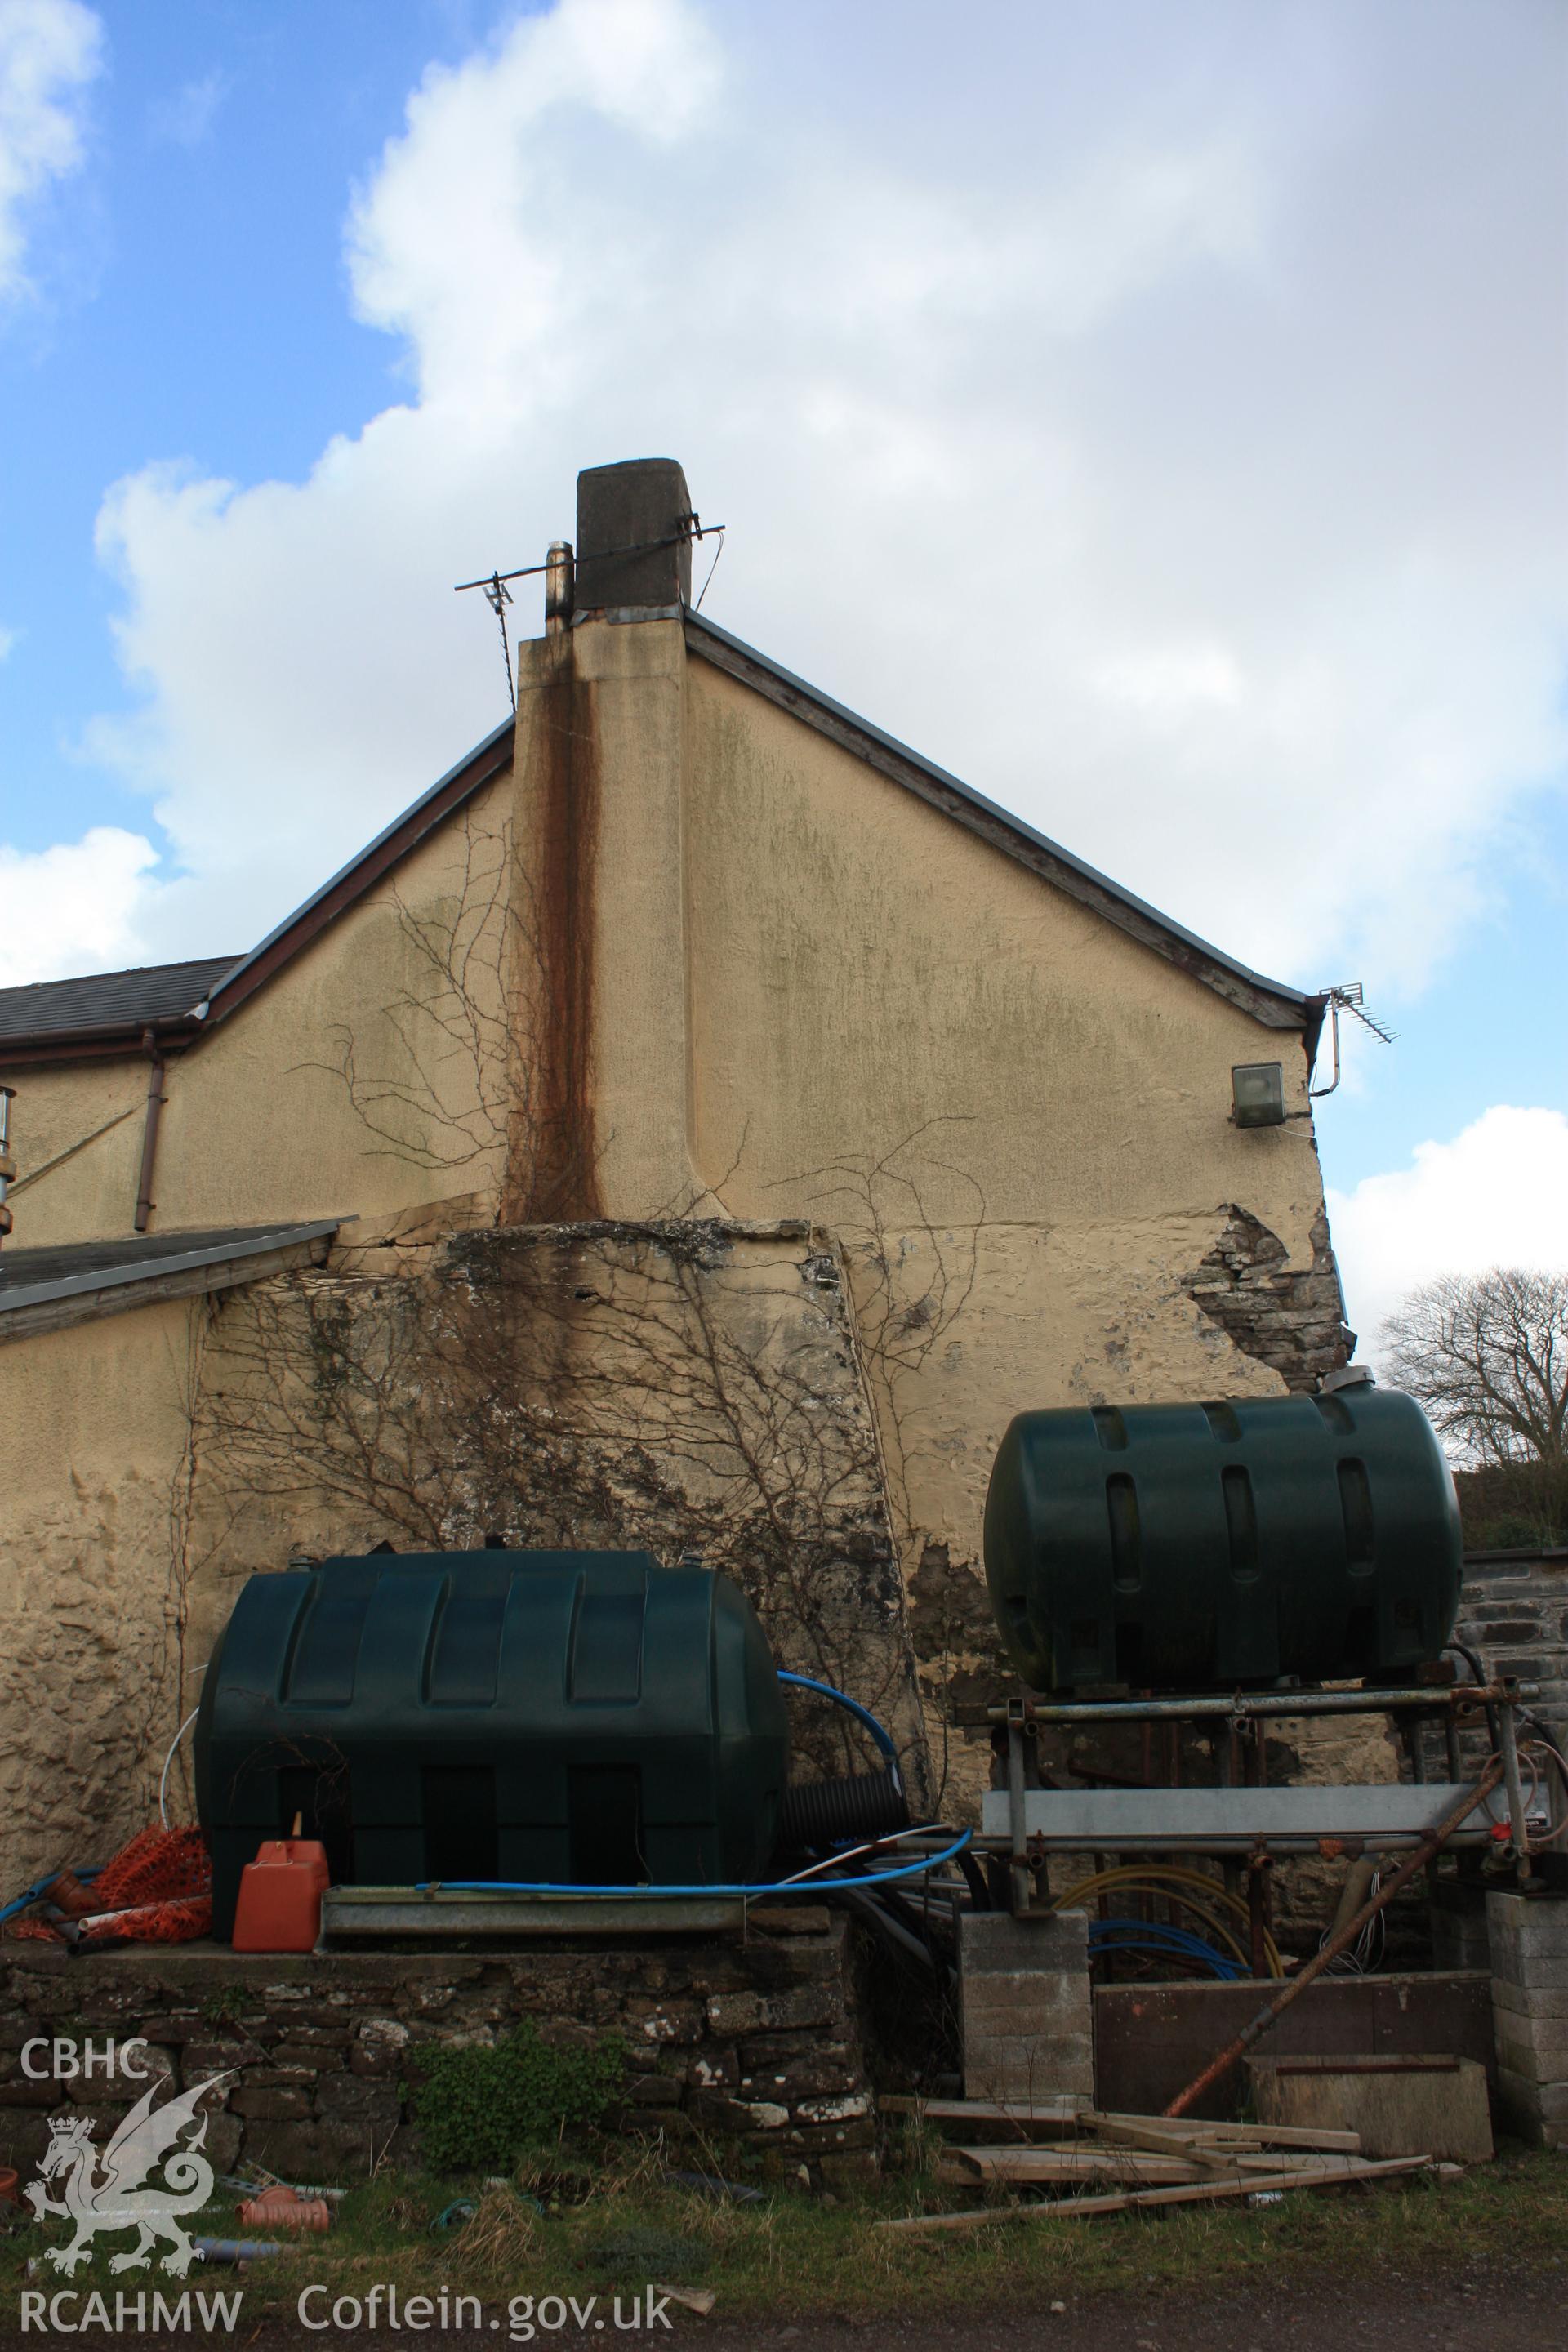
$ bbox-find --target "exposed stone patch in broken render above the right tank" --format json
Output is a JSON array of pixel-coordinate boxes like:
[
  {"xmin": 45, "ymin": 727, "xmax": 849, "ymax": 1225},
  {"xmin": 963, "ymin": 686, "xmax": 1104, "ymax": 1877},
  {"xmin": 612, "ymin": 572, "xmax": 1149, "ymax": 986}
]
[{"xmin": 1183, "ymin": 1202, "xmax": 1356, "ymax": 1392}]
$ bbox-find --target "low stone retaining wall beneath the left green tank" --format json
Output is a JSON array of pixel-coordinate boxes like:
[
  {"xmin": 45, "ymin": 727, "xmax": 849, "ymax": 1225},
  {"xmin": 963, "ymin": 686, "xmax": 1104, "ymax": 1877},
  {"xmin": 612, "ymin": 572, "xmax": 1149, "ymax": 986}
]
[{"xmin": 0, "ymin": 1905, "xmax": 877, "ymax": 2187}]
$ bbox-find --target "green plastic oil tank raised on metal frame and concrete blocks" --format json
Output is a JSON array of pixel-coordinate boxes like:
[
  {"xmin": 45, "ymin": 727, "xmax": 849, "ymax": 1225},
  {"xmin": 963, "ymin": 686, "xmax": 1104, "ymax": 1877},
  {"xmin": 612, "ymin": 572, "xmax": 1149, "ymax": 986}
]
[{"xmin": 985, "ymin": 1383, "xmax": 1462, "ymax": 1691}]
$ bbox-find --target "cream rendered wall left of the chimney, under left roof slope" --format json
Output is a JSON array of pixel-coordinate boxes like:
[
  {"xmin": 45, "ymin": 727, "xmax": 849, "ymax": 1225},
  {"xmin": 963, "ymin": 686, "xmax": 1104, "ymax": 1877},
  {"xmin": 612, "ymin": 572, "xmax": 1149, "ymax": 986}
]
[{"xmin": 0, "ymin": 778, "xmax": 513, "ymax": 1249}]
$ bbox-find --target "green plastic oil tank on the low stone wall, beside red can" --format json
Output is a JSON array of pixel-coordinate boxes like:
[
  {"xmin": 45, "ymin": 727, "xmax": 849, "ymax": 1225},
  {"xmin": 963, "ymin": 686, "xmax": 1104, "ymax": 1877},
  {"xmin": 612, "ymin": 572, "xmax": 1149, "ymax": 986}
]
[{"xmin": 195, "ymin": 1550, "xmax": 790, "ymax": 1938}]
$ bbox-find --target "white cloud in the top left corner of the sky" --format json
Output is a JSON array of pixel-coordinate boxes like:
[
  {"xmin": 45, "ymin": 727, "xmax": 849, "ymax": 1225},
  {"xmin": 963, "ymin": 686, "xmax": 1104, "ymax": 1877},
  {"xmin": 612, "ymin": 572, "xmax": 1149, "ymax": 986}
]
[{"xmin": 0, "ymin": 0, "xmax": 104, "ymax": 301}]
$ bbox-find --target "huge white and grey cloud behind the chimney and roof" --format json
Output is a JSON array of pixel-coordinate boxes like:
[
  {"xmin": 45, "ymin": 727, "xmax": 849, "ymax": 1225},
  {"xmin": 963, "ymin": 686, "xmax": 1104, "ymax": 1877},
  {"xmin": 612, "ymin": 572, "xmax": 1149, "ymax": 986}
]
[{"xmin": 51, "ymin": 0, "xmax": 1568, "ymax": 990}]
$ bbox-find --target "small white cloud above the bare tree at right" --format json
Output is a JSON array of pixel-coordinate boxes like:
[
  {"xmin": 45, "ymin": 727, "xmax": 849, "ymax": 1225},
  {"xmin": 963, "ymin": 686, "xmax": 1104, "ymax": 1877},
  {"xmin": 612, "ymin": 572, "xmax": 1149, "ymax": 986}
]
[{"xmin": 1328, "ymin": 1103, "xmax": 1568, "ymax": 1362}]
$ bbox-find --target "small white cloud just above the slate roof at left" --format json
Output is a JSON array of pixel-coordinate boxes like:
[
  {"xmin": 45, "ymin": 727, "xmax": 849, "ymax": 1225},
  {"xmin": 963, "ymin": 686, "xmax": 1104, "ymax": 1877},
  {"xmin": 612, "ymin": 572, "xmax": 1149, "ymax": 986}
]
[{"xmin": 0, "ymin": 826, "xmax": 158, "ymax": 988}]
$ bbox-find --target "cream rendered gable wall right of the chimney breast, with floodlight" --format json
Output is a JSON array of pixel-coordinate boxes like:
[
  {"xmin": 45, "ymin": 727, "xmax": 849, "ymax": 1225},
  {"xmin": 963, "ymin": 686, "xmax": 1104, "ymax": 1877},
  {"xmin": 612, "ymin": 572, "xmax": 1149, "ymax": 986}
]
[{"xmin": 684, "ymin": 635, "xmax": 1354, "ymax": 1778}]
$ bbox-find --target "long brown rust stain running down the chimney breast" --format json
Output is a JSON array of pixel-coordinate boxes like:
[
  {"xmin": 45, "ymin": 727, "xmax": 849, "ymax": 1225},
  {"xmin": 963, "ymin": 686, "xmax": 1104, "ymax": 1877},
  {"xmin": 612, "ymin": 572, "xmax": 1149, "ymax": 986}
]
[{"xmin": 517, "ymin": 633, "xmax": 602, "ymax": 1225}]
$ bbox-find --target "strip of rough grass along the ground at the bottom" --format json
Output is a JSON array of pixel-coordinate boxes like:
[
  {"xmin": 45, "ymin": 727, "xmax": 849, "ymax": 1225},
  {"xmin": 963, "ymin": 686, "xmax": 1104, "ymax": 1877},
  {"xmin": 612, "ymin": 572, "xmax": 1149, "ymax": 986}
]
[{"xmin": 0, "ymin": 2149, "xmax": 1568, "ymax": 2326}]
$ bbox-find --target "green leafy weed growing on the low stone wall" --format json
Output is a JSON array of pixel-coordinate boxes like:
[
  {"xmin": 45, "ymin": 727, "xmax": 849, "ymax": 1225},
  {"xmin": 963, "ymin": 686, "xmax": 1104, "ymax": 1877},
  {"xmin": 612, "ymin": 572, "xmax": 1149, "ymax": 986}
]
[{"xmin": 412, "ymin": 2020, "xmax": 626, "ymax": 2173}]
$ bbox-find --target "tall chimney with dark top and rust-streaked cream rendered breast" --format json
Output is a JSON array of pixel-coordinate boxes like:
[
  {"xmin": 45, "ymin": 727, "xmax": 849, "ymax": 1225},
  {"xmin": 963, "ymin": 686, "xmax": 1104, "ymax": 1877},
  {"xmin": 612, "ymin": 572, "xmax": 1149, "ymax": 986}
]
[{"xmin": 503, "ymin": 459, "xmax": 712, "ymax": 1223}]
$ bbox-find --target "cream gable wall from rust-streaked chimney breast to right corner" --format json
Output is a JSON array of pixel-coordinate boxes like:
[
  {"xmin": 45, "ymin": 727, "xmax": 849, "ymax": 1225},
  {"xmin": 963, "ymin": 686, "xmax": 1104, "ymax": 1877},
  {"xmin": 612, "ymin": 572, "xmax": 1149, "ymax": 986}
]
[{"xmin": 510, "ymin": 618, "xmax": 1354, "ymax": 1794}]
